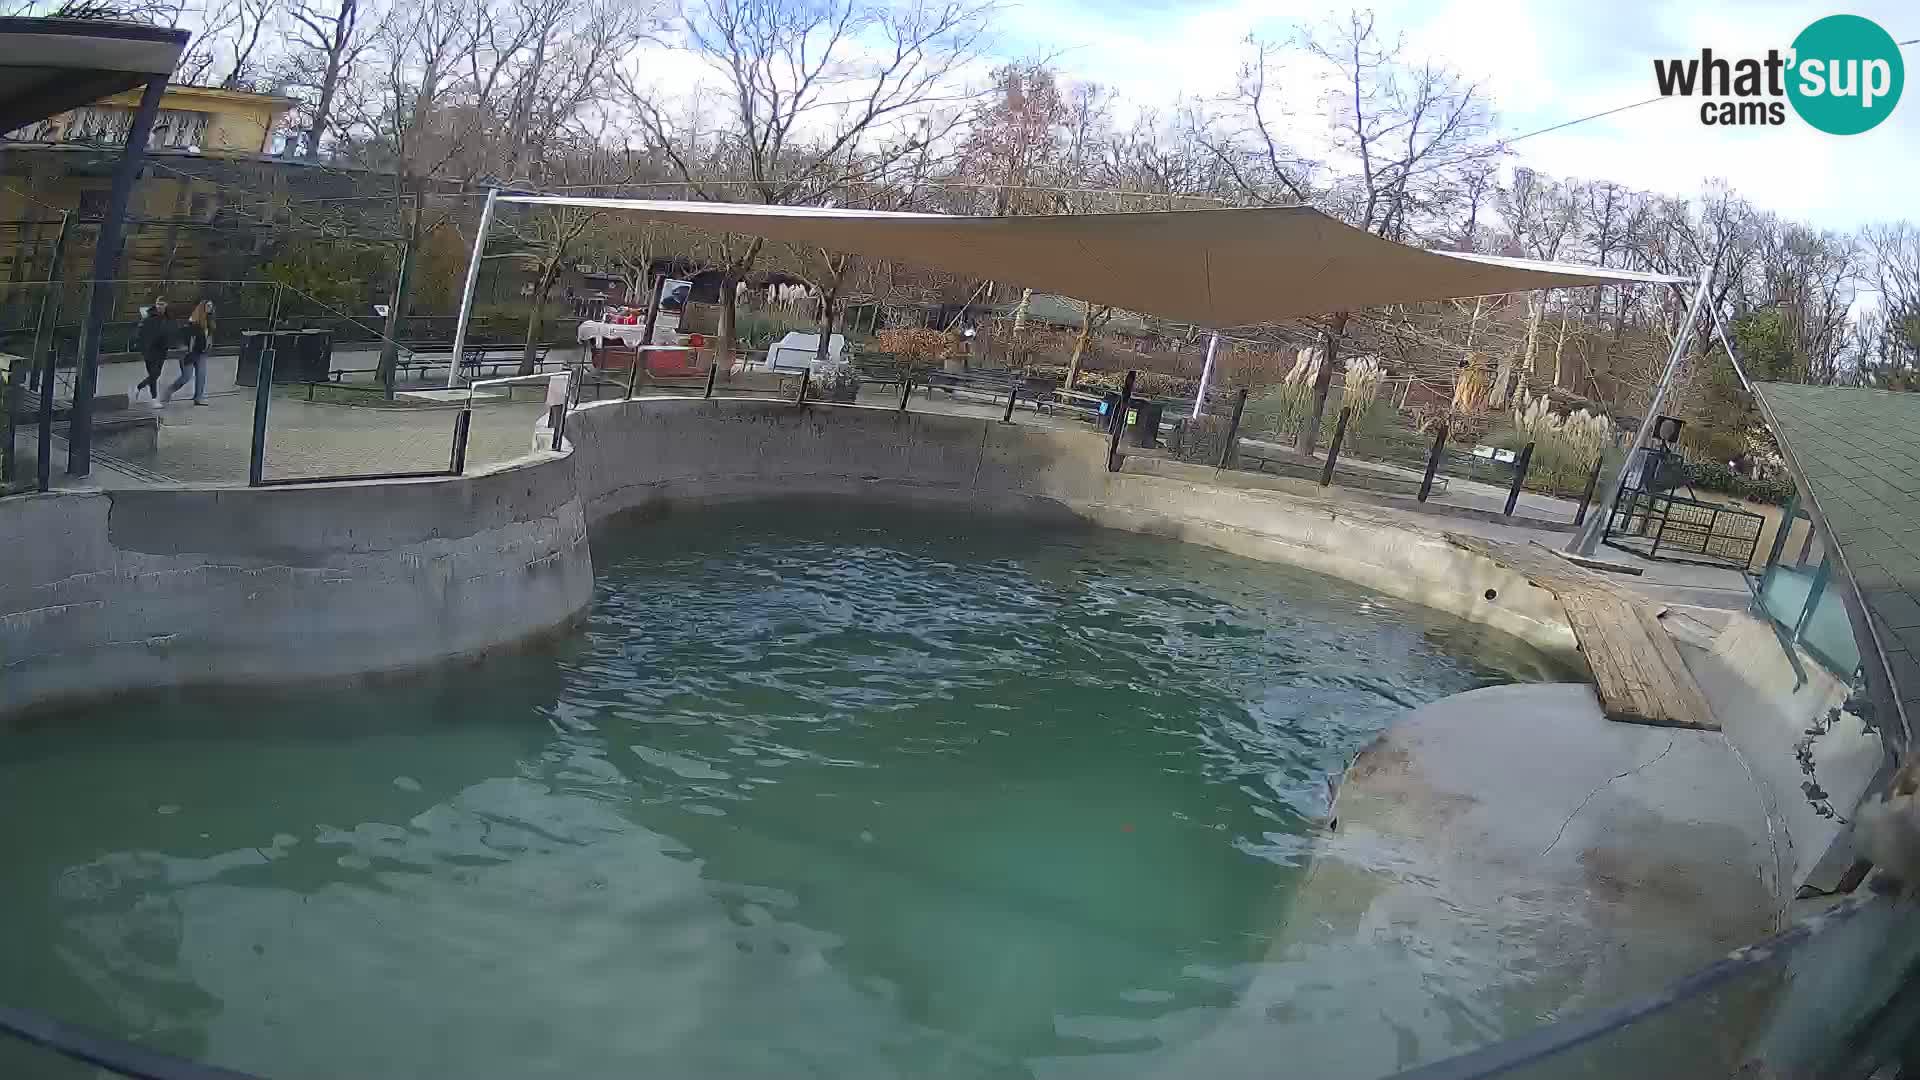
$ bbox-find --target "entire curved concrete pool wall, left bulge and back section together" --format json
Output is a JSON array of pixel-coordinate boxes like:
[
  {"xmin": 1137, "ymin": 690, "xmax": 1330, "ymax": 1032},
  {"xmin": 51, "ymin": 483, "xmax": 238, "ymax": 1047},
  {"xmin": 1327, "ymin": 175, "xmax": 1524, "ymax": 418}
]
[{"xmin": 0, "ymin": 390, "xmax": 1576, "ymax": 715}]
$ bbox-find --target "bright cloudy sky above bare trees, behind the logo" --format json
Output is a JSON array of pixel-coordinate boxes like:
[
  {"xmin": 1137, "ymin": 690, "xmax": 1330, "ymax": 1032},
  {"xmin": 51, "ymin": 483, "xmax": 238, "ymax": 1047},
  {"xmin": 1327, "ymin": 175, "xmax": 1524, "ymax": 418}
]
[{"xmin": 996, "ymin": 0, "xmax": 1920, "ymax": 229}]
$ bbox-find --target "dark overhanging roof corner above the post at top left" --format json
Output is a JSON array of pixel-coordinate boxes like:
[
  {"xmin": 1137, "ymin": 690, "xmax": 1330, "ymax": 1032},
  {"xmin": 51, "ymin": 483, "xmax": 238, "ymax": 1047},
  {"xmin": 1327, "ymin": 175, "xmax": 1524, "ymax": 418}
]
[{"xmin": 0, "ymin": 19, "xmax": 188, "ymax": 131}]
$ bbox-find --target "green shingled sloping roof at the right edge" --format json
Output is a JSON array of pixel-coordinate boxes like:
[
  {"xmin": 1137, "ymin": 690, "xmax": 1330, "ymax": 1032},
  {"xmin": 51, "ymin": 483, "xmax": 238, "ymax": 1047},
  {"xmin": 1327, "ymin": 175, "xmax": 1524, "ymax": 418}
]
[{"xmin": 1755, "ymin": 382, "xmax": 1920, "ymax": 749}]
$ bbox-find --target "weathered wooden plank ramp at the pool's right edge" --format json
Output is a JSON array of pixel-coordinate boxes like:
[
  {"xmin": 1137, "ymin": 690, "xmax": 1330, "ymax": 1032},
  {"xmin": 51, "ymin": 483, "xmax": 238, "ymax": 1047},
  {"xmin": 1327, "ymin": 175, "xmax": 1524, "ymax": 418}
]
[{"xmin": 1448, "ymin": 534, "xmax": 1720, "ymax": 730}]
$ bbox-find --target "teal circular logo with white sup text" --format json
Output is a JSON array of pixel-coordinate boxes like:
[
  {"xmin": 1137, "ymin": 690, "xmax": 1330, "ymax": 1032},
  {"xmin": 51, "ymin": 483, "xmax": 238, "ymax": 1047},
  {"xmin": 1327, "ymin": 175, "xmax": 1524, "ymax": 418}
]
[{"xmin": 1788, "ymin": 15, "xmax": 1907, "ymax": 135}]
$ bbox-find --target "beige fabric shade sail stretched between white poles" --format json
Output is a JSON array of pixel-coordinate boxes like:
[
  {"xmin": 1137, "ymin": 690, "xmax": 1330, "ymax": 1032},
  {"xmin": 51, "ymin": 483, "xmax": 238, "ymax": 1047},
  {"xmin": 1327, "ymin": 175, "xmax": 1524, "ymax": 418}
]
[{"xmin": 499, "ymin": 194, "xmax": 1686, "ymax": 327}]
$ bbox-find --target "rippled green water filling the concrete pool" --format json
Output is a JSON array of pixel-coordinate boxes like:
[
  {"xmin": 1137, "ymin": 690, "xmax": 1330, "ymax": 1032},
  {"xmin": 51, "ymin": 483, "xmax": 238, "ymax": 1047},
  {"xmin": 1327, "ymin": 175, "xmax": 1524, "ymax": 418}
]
[{"xmin": 0, "ymin": 503, "xmax": 1557, "ymax": 1078}]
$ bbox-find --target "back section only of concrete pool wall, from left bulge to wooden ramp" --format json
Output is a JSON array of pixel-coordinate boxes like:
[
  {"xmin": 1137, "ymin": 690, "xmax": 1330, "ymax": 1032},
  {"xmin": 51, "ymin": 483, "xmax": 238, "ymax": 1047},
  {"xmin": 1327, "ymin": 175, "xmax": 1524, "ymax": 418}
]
[{"xmin": 566, "ymin": 398, "xmax": 1578, "ymax": 661}]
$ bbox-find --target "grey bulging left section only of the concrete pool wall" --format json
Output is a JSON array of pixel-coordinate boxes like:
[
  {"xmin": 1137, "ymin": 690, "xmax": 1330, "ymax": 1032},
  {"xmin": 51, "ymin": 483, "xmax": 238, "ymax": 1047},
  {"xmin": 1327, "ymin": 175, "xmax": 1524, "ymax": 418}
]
[{"xmin": 0, "ymin": 454, "xmax": 593, "ymax": 713}]
